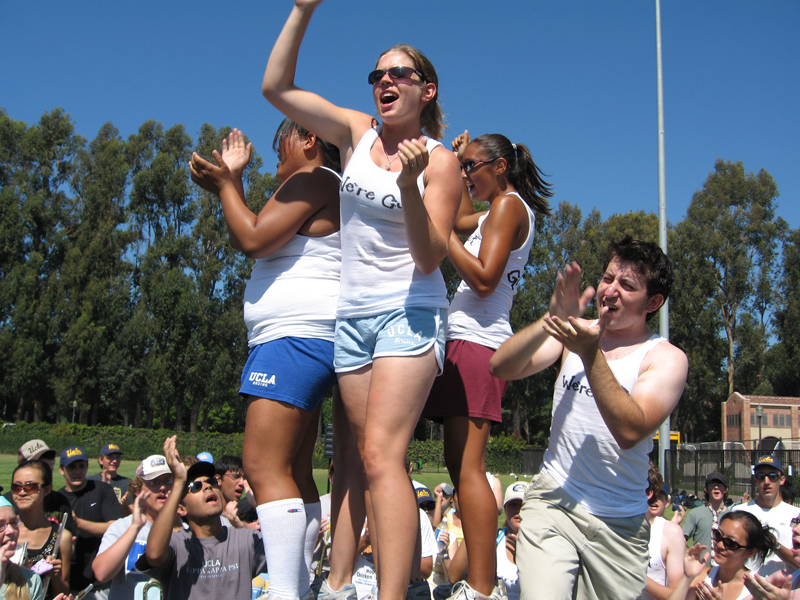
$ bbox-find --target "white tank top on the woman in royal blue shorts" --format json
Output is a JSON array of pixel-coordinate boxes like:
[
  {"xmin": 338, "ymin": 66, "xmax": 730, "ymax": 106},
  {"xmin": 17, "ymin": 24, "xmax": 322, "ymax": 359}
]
[{"xmin": 244, "ymin": 231, "xmax": 342, "ymax": 348}]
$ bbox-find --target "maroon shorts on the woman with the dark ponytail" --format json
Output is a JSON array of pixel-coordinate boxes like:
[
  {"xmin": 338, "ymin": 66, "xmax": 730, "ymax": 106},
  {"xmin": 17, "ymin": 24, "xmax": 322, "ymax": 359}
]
[{"xmin": 422, "ymin": 340, "xmax": 508, "ymax": 423}]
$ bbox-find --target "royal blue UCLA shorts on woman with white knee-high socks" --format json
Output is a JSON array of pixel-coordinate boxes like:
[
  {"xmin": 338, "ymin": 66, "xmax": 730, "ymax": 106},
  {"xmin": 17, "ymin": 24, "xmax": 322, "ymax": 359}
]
[{"xmin": 239, "ymin": 337, "xmax": 336, "ymax": 411}]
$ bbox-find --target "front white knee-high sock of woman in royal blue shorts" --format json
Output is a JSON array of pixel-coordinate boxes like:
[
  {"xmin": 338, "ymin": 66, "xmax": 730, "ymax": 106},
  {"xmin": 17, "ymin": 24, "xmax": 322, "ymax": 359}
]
[{"xmin": 256, "ymin": 498, "xmax": 308, "ymax": 600}]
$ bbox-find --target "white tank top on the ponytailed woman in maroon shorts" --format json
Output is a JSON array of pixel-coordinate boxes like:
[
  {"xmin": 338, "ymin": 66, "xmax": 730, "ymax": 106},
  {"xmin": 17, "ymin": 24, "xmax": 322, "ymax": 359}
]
[{"xmin": 447, "ymin": 192, "xmax": 536, "ymax": 350}]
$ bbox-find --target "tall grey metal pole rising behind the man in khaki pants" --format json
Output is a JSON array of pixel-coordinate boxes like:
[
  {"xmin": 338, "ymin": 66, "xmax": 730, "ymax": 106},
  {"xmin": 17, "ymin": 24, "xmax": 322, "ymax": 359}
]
[{"xmin": 656, "ymin": 0, "xmax": 670, "ymax": 472}]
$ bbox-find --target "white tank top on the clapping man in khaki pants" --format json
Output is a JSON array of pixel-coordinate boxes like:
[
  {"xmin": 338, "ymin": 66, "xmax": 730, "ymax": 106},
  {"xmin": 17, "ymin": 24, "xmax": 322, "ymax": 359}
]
[{"xmin": 542, "ymin": 335, "xmax": 664, "ymax": 518}]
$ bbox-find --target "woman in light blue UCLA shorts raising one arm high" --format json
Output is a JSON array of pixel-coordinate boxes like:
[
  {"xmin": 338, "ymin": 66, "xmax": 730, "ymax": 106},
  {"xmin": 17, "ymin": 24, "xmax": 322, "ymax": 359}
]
[{"xmin": 262, "ymin": 0, "xmax": 460, "ymax": 600}]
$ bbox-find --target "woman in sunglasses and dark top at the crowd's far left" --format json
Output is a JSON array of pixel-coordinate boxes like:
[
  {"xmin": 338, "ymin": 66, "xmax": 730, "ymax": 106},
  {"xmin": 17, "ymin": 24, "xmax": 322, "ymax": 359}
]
[{"xmin": 11, "ymin": 460, "xmax": 72, "ymax": 597}]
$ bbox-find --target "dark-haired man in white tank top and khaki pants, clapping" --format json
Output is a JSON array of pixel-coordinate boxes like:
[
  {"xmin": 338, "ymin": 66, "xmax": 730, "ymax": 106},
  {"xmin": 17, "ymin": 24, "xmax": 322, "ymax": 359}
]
[{"xmin": 490, "ymin": 237, "xmax": 688, "ymax": 600}]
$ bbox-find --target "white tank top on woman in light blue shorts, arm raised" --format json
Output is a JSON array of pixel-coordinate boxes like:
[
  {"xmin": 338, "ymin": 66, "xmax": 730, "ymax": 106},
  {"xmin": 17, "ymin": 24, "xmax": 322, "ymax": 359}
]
[{"xmin": 336, "ymin": 127, "xmax": 448, "ymax": 318}]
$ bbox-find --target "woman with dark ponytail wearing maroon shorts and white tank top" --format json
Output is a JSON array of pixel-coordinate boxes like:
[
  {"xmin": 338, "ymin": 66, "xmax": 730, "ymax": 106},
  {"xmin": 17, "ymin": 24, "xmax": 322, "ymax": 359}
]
[{"xmin": 423, "ymin": 131, "xmax": 553, "ymax": 600}]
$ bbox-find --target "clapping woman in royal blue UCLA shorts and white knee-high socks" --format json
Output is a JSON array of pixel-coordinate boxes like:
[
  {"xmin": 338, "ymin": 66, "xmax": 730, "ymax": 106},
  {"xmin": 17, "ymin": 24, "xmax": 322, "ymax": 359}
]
[{"xmin": 190, "ymin": 119, "xmax": 341, "ymax": 600}]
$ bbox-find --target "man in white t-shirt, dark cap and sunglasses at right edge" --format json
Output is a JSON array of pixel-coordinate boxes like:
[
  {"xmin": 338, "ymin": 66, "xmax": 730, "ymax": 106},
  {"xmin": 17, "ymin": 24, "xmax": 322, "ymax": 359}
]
[{"xmin": 732, "ymin": 454, "xmax": 800, "ymax": 577}]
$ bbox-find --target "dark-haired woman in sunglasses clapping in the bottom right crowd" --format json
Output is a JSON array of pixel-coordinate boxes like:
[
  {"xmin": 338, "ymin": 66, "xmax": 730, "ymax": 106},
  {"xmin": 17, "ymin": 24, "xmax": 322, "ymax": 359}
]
[{"xmin": 669, "ymin": 511, "xmax": 778, "ymax": 600}]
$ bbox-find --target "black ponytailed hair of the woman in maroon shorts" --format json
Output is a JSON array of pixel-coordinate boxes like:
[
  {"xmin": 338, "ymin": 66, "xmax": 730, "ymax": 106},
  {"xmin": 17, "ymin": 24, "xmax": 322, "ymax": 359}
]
[{"xmin": 472, "ymin": 133, "xmax": 553, "ymax": 215}]
